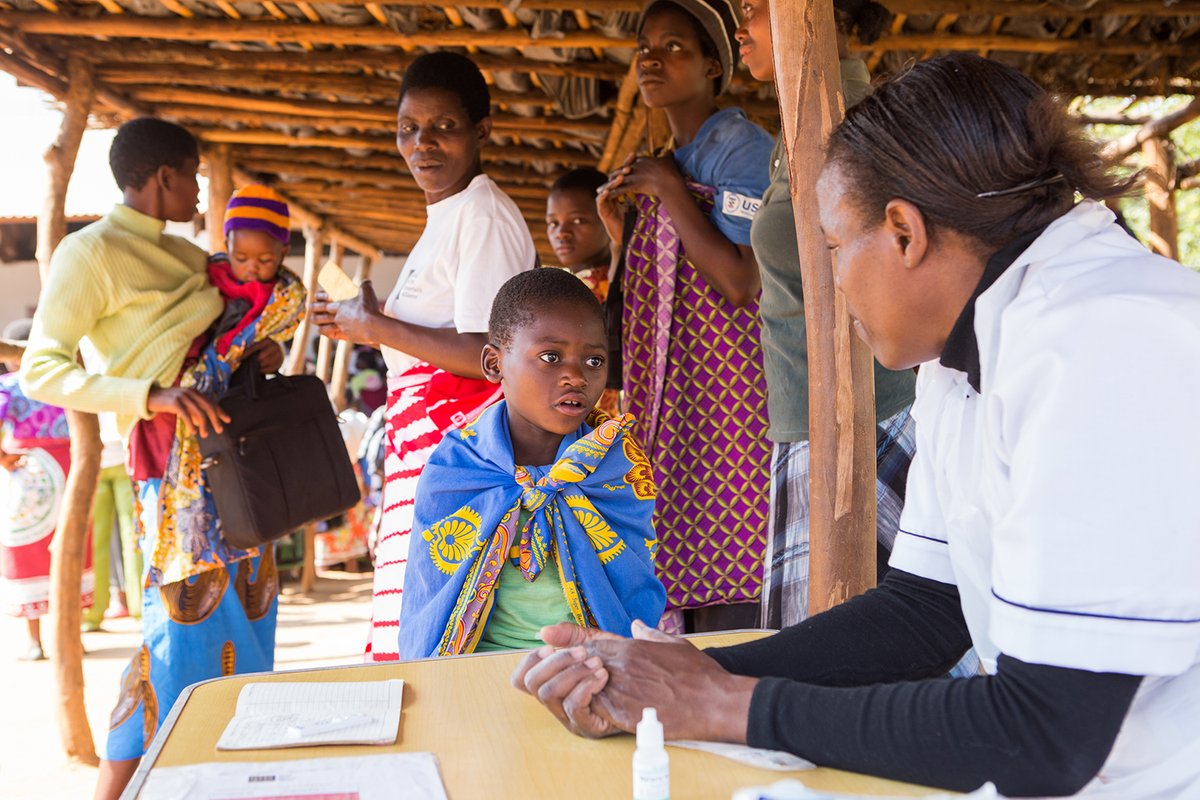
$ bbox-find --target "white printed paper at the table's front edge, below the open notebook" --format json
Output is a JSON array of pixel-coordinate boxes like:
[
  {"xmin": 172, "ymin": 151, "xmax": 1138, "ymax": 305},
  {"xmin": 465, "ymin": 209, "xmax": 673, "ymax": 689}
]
[{"xmin": 138, "ymin": 753, "xmax": 446, "ymax": 800}]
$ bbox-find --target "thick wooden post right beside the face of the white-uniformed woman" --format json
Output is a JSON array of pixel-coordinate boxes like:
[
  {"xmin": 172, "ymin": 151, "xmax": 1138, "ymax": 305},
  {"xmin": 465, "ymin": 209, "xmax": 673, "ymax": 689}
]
[{"xmin": 770, "ymin": 0, "xmax": 875, "ymax": 614}]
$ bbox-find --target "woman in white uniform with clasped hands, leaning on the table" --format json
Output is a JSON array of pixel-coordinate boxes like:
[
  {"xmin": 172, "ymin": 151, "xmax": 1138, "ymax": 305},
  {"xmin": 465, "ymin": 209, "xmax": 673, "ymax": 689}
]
[{"xmin": 515, "ymin": 53, "xmax": 1200, "ymax": 800}]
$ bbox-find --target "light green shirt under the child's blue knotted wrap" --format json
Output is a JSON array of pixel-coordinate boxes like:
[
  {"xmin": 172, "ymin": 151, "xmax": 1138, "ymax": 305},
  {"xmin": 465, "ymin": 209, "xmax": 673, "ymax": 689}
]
[{"xmin": 475, "ymin": 510, "xmax": 575, "ymax": 652}]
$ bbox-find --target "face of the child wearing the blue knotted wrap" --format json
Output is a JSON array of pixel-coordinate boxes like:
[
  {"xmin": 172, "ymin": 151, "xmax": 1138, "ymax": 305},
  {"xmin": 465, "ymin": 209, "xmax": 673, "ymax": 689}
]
[{"xmin": 484, "ymin": 302, "xmax": 608, "ymax": 467}]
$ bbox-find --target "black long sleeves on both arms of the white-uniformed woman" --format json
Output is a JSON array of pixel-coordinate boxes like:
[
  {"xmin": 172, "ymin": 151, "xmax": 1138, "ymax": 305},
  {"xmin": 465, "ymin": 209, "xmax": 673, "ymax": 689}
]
[{"xmin": 707, "ymin": 570, "xmax": 1141, "ymax": 796}]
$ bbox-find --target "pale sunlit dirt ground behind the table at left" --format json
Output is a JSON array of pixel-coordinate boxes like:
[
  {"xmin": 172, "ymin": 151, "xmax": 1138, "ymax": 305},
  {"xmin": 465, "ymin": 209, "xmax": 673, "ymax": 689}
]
[{"xmin": 0, "ymin": 572, "xmax": 371, "ymax": 800}]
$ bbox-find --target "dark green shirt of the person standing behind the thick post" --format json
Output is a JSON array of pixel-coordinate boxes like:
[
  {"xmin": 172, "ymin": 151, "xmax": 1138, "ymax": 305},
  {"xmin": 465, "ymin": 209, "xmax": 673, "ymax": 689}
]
[{"xmin": 750, "ymin": 59, "xmax": 916, "ymax": 441}]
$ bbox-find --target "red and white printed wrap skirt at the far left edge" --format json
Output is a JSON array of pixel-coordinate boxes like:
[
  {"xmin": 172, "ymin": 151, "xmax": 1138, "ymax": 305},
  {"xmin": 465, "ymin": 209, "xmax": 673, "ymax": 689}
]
[{"xmin": 0, "ymin": 439, "xmax": 93, "ymax": 619}]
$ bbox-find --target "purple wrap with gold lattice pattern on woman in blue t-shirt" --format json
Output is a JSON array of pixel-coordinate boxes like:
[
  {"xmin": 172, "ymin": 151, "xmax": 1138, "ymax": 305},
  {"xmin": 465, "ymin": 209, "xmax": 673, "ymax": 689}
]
[{"xmin": 622, "ymin": 182, "xmax": 770, "ymax": 608}]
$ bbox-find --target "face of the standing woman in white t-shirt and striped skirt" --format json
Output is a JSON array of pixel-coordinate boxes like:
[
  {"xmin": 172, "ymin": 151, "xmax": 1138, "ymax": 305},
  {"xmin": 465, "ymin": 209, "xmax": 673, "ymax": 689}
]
[{"xmin": 396, "ymin": 89, "xmax": 492, "ymax": 203}]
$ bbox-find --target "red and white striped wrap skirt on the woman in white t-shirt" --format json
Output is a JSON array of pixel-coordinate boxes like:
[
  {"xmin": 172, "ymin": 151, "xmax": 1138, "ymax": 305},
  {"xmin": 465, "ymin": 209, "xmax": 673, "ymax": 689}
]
[{"xmin": 366, "ymin": 361, "xmax": 500, "ymax": 661}]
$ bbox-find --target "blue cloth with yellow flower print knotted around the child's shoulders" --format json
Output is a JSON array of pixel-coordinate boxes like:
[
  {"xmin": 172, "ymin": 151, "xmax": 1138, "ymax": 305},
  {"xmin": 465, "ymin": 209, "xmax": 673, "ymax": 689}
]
[{"xmin": 400, "ymin": 403, "xmax": 666, "ymax": 658}]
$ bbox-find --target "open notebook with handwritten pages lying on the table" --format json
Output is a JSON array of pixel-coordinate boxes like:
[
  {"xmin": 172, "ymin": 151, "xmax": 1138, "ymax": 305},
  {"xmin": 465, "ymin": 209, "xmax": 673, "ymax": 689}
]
[{"xmin": 217, "ymin": 680, "xmax": 404, "ymax": 750}]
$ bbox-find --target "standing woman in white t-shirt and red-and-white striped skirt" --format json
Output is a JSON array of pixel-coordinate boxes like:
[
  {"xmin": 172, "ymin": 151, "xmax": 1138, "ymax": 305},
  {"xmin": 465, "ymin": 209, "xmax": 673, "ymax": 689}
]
[{"xmin": 313, "ymin": 53, "xmax": 536, "ymax": 661}]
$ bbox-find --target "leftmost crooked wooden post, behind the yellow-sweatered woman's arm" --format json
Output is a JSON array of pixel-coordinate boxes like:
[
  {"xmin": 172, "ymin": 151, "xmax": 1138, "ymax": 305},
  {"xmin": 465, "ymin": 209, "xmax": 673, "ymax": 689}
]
[{"xmin": 37, "ymin": 56, "xmax": 100, "ymax": 764}]
